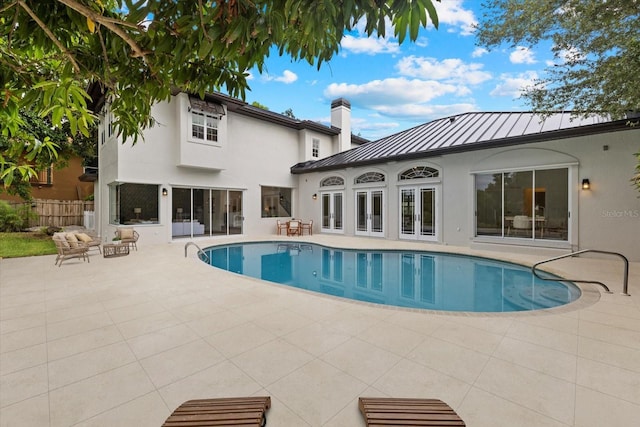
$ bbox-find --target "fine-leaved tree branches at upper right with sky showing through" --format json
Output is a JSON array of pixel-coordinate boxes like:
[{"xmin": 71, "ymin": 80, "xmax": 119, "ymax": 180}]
[{"xmin": 477, "ymin": 0, "xmax": 640, "ymax": 118}]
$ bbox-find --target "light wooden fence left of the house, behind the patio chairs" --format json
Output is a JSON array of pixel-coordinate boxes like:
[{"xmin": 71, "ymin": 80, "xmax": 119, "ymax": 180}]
[{"xmin": 10, "ymin": 199, "xmax": 94, "ymax": 227}]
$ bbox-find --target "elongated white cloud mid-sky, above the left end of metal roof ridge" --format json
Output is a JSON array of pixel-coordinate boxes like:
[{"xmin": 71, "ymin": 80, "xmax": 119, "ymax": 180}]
[{"xmin": 396, "ymin": 56, "xmax": 491, "ymax": 85}]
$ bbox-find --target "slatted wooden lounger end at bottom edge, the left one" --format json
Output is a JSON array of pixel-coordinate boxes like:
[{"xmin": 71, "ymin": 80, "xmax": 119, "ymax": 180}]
[{"xmin": 162, "ymin": 396, "xmax": 271, "ymax": 427}]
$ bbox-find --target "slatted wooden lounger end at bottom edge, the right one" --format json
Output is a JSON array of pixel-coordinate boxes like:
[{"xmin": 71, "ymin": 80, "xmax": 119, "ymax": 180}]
[{"xmin": 358, "ymin": 397, "xmax": 466, "ymax": 427}]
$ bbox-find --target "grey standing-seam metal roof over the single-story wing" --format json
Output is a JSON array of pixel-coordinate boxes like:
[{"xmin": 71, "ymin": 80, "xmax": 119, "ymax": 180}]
[{"xmin": 291, "ymin": 112, "xmax": 629, "ymax": 174}]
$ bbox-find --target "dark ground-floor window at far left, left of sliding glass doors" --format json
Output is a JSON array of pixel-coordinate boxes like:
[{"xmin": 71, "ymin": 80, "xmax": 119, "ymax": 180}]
[{"xmin": 109, "ymin": 183, "xmax": 160, "ymax": 225}]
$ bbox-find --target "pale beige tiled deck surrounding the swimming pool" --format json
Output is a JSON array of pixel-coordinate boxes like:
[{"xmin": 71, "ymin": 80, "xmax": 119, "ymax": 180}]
[{"xmin": 0, "ymin": 235, "xmax": 640, "ymax": 427}]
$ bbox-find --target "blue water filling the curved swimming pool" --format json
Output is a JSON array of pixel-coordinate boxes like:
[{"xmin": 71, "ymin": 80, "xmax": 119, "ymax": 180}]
[{"xmin": 205, "ymin": 242, "xmax": 580, "ymax": 312}]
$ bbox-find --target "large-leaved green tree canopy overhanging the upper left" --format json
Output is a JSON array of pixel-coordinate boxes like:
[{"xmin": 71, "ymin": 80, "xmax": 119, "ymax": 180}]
[{"xmin": 0, "ymin": 0, "xmax": 439, "ymax": 187}]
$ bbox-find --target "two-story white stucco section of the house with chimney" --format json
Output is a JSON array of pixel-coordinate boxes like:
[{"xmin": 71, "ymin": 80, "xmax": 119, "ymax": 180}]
[{"xmin": 95, "ymin": 93, "xmax": 367, "ymax": 243}]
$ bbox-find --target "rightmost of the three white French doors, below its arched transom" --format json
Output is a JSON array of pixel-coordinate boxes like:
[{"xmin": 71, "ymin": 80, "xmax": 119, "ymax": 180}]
[{"xmin": 400, "ymin": 187, "xmax": 437, "ymax": 241}]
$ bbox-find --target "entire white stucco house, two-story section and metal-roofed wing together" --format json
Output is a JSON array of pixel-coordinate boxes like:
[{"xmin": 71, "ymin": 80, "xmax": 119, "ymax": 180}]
[{"xmin": 96, "ymin": 93, "xmax": 640, "ymax": 261}]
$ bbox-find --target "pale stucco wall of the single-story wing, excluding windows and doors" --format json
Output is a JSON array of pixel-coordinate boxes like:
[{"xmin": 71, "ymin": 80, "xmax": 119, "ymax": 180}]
[{"xmin": 298, "ymin": 129, "xmax": 640, "ymax": 261}]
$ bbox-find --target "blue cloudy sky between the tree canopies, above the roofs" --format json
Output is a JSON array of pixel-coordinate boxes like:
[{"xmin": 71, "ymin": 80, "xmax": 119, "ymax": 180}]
[{"xmin": 235, "ymin": 0, "xmax": 554, "ymax": 140}]
